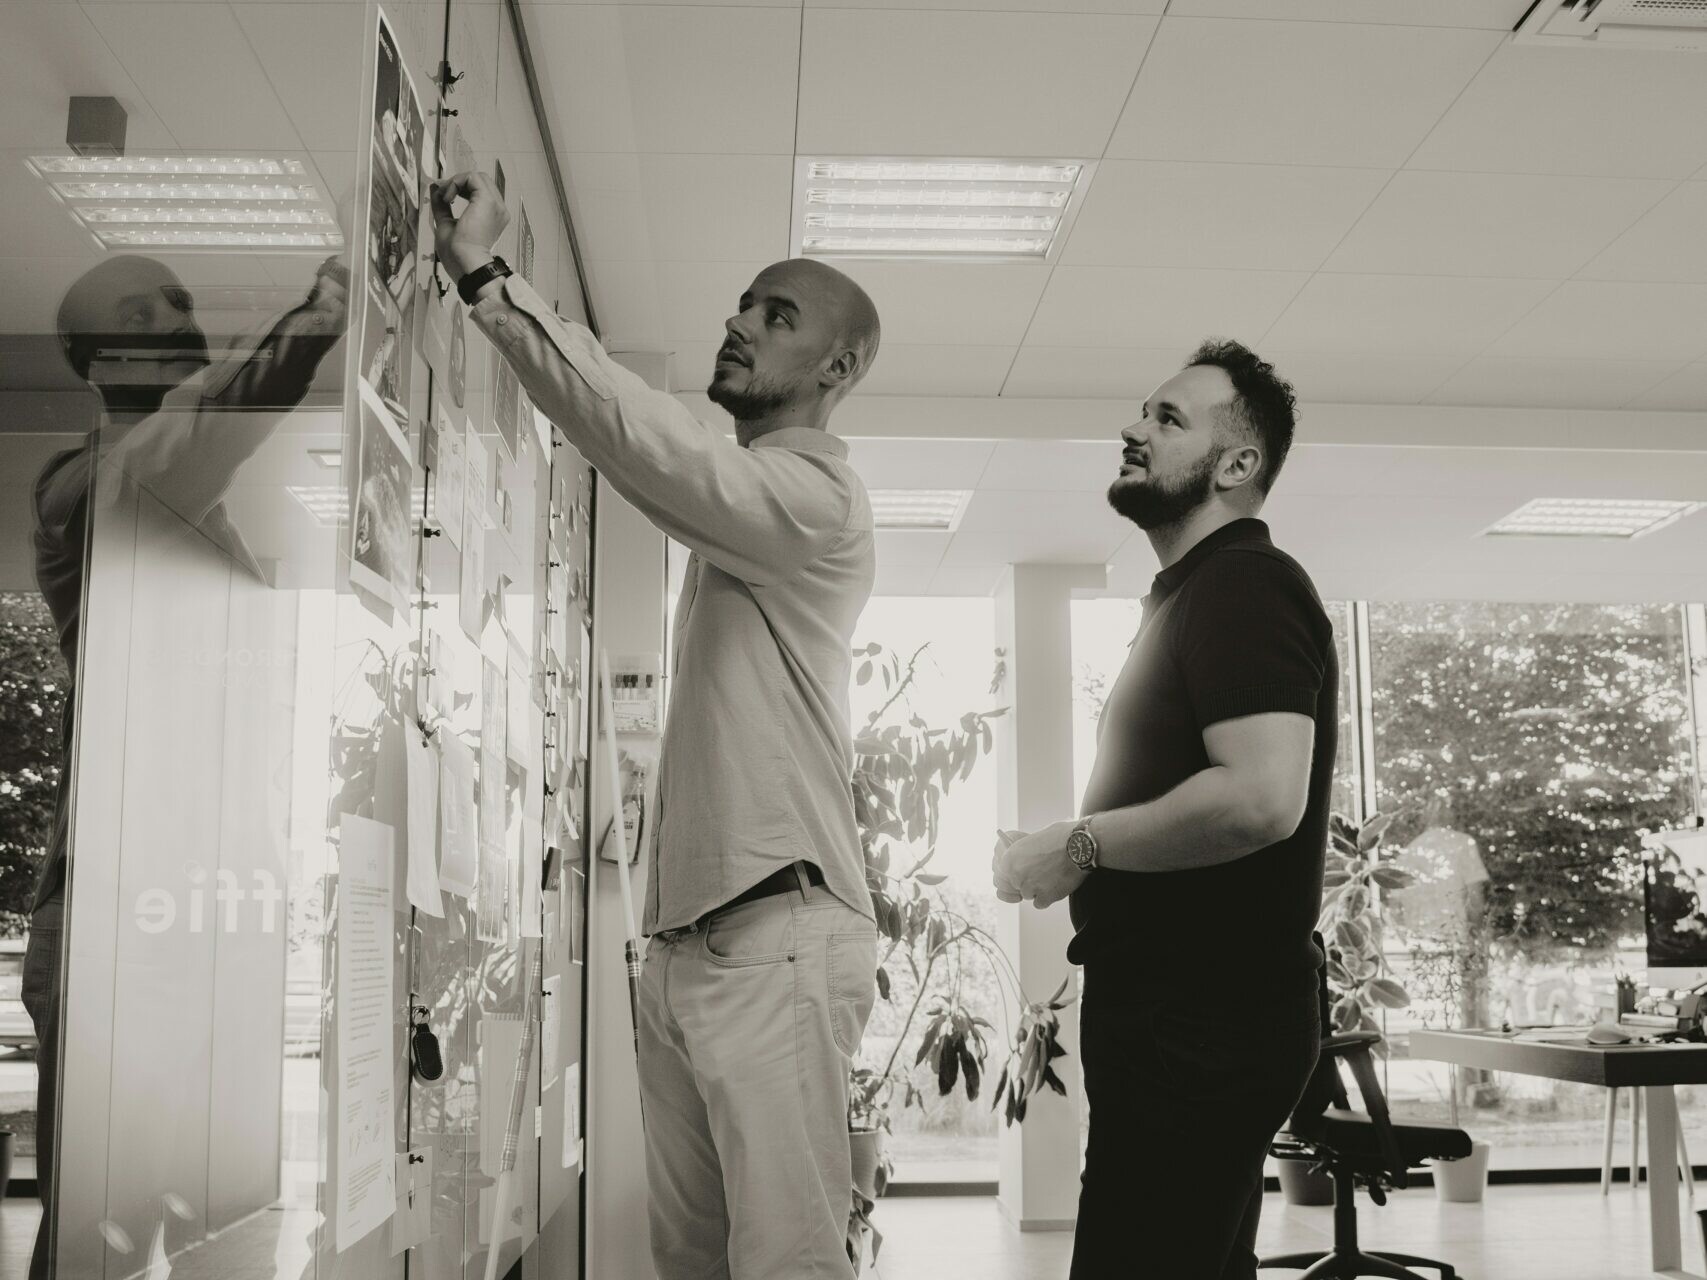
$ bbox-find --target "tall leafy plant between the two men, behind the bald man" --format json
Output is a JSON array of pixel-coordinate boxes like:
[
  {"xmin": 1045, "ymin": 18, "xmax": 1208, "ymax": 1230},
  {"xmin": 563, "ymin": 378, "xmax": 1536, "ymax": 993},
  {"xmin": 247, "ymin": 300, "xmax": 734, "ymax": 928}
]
[{"xmin": 848, "ymin": 643, "xmax": 1070, "ymax": 1271}]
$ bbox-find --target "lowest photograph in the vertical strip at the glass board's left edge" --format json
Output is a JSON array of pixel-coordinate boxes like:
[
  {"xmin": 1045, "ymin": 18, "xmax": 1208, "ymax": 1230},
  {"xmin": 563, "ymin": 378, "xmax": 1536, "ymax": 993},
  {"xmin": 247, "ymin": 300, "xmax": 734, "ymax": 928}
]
[{"xmin": 350, "ymin": 379, "xmax": 415, "ymax": 609}]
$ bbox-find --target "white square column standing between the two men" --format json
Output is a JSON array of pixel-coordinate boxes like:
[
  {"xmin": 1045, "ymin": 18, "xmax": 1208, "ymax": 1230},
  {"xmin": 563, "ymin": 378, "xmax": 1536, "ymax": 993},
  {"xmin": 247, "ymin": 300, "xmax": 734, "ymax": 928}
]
[{"xmin": 995, "ymin": 565, "xmax": 1108, "ymax": 1231}]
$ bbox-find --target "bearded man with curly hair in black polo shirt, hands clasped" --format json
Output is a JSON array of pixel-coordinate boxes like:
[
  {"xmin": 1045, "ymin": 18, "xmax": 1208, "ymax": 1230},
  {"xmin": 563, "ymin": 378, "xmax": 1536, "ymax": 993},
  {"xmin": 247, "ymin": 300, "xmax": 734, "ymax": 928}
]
[{"xmin": 995, "ymin": 341, "xmax": 1338, "ymax": 1280}]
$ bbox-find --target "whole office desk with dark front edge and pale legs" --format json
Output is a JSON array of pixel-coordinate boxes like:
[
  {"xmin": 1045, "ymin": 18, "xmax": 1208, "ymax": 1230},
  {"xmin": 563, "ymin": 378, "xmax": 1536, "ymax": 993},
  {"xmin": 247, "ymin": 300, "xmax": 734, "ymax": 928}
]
[{"xmin": 1410, "ymin": 1031, "xmax": 1707, "ymax": 1280}]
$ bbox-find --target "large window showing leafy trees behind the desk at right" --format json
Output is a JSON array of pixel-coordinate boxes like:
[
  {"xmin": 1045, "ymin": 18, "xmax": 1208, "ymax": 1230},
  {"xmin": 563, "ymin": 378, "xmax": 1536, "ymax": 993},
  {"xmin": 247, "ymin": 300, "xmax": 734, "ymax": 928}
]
[{"xmin": 1369, "ymin": 602, "xmax": 1707, "ymax": 1167}]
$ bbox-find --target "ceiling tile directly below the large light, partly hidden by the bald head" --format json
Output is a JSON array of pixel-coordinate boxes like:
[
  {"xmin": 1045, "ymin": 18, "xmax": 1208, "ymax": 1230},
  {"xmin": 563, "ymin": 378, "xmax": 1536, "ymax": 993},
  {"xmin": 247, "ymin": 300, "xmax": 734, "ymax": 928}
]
[{"xmin": 833, "ymin": 259, "xmax": 1050, "ymax": 348}]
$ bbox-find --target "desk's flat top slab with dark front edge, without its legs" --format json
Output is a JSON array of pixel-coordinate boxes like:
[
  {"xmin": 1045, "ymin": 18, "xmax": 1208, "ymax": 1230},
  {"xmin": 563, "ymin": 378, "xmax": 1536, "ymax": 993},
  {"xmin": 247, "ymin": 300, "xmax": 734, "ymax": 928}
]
[{"xmin": 1410, "ymin": 1031, "xmax": 1707, "ymax": 1087}]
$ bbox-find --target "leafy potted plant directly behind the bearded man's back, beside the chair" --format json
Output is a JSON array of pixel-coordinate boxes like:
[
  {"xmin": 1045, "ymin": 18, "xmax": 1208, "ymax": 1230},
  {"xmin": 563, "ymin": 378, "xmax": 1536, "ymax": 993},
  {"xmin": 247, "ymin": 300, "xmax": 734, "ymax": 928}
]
[{"xmin": 1279, "ymin": 814, "xmax": 1410, "ymax": 1205}]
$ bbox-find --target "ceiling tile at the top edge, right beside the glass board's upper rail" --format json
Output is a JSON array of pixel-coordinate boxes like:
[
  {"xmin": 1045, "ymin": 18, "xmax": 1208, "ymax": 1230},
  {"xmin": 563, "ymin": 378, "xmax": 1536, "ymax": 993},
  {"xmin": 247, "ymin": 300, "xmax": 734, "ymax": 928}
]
[{"xmin": 529, "ymin": 5, "xmax": 801, "ymax": 155}]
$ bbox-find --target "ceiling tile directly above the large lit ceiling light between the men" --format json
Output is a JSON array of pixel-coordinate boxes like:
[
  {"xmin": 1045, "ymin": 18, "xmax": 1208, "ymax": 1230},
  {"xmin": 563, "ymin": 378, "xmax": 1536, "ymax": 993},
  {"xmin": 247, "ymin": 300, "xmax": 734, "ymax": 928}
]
[{"xmin": 792, "ymin": 9, "xmax": 1156, "ymax": 159}]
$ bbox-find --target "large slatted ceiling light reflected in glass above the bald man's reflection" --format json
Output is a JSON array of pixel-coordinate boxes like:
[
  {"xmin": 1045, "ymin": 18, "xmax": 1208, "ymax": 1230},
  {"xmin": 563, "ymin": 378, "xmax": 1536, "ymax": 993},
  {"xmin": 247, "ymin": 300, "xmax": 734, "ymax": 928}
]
[{"xmin": 29, "ymin": 155, "xmax": 343, "ymax": 253}]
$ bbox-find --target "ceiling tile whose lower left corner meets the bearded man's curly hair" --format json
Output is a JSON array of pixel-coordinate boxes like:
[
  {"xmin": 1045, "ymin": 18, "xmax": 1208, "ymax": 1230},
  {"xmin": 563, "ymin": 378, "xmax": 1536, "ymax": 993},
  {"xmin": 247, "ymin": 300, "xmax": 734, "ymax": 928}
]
[{"xmin": 1261, "ymin": 275, "xmax": 1553, "ymax": 357}]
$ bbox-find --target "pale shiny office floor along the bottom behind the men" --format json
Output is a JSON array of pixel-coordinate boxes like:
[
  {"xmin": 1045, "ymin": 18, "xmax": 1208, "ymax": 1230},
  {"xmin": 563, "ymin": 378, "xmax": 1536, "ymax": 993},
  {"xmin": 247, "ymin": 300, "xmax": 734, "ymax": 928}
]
[{"xmin": 876, "ymin": 1184, "xmax": 1707, "ymax": 1280}]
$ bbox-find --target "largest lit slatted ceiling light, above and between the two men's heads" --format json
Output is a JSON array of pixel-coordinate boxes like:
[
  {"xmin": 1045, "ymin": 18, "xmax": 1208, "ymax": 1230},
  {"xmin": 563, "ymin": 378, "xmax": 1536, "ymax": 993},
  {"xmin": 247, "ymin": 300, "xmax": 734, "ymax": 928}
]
[{"xmin": 794, "ymin": 157, "xmax": 1094, "ymax": 263}]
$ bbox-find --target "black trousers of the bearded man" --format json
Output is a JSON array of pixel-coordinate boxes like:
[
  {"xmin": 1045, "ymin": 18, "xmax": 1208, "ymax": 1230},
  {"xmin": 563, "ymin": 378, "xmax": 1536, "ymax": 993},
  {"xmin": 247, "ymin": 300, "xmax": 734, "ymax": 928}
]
[{"xmin": 1072, "ymin": 981, "xmax": 1321, "ymax": 1280}]
